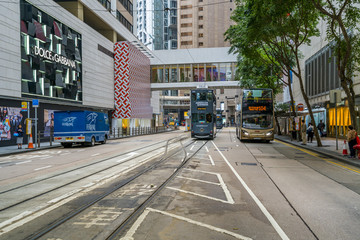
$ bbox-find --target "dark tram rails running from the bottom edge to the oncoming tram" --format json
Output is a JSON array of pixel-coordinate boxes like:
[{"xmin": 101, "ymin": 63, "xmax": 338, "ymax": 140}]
[{"xmin": 16, "ymin": 141, "xmax": 208, "ymax": 240}]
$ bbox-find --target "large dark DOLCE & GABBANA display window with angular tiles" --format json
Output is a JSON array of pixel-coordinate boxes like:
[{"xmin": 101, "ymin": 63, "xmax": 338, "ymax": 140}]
[{"xmin": 20, "ymin": 0, "xmax": 82, "ymax": 101}]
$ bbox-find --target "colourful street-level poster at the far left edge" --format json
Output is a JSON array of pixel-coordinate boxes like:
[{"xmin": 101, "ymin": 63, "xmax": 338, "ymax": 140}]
[{"xmin": 0, "ymin": 106, "xmax": 25, "ymax": 141}]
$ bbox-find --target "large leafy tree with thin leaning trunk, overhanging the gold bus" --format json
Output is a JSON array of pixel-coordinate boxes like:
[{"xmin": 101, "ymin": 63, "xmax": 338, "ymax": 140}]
[{"xmin": 228, "ymin": 0, "xmax": 321, "ymax": 146}]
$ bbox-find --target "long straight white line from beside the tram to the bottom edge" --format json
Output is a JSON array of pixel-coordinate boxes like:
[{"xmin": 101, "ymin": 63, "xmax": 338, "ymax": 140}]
[{"xmin": 211, "ymin": 141, "xmax": 290, "ymax": 240}]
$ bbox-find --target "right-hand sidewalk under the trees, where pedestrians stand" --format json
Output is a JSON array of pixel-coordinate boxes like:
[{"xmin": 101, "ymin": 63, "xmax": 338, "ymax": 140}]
[{"xmin": 275, "ymin": 135, "xmax": 360, "ymax": 167}]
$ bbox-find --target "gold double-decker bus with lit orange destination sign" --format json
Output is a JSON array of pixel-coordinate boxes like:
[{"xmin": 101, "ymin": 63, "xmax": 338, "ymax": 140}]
[{"xmin": 236, "ymin": 89, "xmax": 275, "ymax": 142}]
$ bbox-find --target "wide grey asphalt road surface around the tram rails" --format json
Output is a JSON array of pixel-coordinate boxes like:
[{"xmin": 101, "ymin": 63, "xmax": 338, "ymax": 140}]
[{"xmin": 0, "ymin": 128, "xmax": 360, "ymax": 240}]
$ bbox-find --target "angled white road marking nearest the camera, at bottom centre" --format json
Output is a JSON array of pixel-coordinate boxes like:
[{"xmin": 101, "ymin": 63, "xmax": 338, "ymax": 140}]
[{"xmin": 130, "ymin": 208, "xmax": 252, "ymax": 240}]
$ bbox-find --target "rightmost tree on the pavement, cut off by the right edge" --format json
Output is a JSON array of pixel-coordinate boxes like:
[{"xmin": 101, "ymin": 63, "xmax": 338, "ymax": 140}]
[{"xmin": 311, "ymin": 0, "xmax": 360, "ymax": 130}]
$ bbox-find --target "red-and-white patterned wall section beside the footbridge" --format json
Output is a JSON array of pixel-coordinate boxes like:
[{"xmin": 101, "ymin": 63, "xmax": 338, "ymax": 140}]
[{"xmin": 113, "ymin": 42, "xmax": 152, "ymax": 119}]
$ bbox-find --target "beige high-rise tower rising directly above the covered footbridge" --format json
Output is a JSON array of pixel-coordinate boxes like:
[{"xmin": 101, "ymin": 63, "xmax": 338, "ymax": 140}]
[{"xmin": 178, "ymin": 0, "xmax": 235, "ymax": 49}]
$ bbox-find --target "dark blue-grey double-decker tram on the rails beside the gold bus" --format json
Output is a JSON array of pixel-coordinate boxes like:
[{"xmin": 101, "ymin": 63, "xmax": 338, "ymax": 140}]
[{"xmin": 190, "ymin": 88, "xmax": 216, "ymax": 139}]
